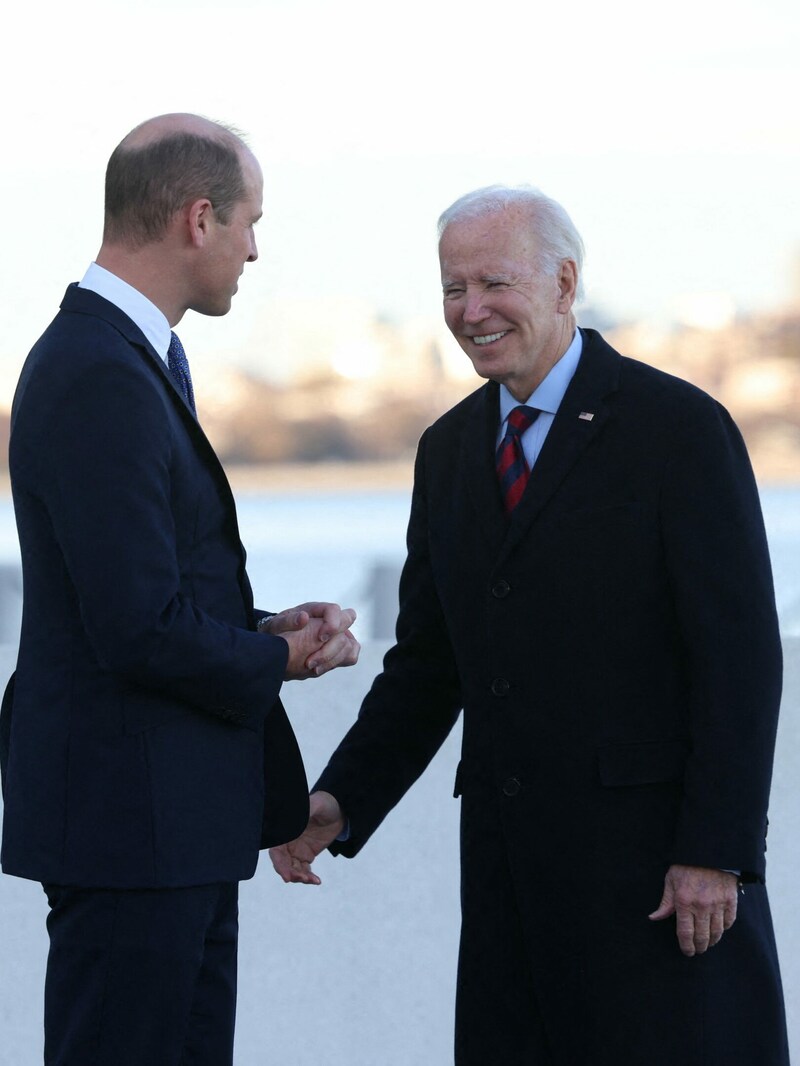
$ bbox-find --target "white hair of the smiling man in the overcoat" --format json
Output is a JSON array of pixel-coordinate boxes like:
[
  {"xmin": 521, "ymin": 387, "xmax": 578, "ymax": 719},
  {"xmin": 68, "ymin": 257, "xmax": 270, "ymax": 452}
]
[{"xmin": 437, "ymin": 185, "xmax": 583, "ymax": 300}]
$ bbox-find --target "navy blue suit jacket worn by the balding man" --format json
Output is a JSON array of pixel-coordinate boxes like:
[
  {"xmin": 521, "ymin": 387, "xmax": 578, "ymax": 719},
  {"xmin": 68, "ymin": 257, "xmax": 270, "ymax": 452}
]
[{"xmin": 0, "ymin": 286, "xmax": 307, "ymax": 888}]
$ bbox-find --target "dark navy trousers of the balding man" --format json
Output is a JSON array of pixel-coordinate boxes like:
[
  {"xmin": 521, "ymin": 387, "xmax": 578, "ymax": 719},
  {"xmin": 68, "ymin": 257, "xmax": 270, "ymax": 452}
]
[{"xmin": 44, "ymin": 884, "xmax": 239, "ymax": 1066}]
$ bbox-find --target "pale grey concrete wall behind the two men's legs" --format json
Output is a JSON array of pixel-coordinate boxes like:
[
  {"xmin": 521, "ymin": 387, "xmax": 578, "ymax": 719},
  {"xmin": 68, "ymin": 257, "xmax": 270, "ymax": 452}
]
[{"xmin": 0, "ymin": 637, "xmax": 800, "ymax": 1066}]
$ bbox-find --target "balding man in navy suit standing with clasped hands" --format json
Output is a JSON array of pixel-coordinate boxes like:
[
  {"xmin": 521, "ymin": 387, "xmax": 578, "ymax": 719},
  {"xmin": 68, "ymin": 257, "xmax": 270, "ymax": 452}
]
[{"xmin": 0, "ymin": 115, "xmax": 358, "ymax": 1066}]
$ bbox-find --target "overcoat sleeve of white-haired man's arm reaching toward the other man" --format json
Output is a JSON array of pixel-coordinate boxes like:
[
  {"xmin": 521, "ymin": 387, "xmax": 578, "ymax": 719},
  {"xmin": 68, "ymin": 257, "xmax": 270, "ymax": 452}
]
[{"xmin": 315, "ymin": 428, "xmax": 461, "ymax": 856}]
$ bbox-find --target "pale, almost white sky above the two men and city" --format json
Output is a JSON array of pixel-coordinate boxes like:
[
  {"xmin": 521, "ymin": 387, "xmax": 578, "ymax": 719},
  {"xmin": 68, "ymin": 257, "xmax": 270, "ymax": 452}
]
[{"xmin": 0, "ymin": 0, "xmax": 800, "ymax": 388}]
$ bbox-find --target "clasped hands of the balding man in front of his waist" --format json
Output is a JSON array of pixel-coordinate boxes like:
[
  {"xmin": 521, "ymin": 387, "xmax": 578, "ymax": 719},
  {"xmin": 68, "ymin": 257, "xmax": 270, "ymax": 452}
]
[{"xmin": 262, "ymin": 602, "xmax": 361, "ymax": 681}]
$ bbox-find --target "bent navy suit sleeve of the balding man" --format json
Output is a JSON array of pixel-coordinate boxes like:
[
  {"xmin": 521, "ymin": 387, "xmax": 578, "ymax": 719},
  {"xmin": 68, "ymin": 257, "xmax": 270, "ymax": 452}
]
[{"xmin": 31, "ymin": 357, "xmax": 288, "ymax": 728}]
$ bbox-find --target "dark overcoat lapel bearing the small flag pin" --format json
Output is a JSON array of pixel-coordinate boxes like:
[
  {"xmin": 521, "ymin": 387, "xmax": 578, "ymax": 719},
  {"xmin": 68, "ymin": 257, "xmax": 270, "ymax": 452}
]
[{"xmin": 503, "ymin": 329, "xmax": 620, "ymax": 554}]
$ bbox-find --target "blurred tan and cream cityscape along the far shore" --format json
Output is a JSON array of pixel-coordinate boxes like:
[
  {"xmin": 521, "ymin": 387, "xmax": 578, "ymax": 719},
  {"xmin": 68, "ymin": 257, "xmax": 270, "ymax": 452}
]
[{"xmin": 0, "ymin": 294, "xmax": 800, "ymax": 482}]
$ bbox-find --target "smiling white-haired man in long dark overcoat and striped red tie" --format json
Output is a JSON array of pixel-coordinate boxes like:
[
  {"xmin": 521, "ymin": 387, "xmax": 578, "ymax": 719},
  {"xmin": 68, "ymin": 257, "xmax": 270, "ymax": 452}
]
[{"xmin": 273, "ymin": 187, "xmax": 788, "ymax": 1066}]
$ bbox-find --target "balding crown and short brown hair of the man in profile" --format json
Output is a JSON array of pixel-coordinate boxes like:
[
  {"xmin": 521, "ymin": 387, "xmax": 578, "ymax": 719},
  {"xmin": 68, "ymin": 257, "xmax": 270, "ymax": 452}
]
[{"xmin": 103, "ymin": 114, "xmax": 250, "ymax": 249}]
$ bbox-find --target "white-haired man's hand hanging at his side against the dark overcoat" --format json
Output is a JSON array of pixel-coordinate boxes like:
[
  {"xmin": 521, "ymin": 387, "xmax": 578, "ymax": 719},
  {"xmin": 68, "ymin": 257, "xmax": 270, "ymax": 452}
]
[{"xmin": 650, "ymin": 866, "xmax": 737, "ymax": 956}]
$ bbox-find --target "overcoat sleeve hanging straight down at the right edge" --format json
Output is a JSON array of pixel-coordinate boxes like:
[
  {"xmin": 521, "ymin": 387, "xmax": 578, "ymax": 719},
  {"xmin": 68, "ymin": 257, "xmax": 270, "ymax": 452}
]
[{"xmin": 660, "ymin": 398, "xmax": 782, "ymax": 879}]
